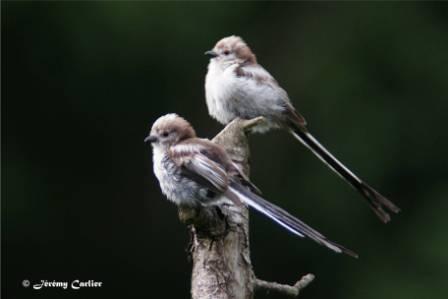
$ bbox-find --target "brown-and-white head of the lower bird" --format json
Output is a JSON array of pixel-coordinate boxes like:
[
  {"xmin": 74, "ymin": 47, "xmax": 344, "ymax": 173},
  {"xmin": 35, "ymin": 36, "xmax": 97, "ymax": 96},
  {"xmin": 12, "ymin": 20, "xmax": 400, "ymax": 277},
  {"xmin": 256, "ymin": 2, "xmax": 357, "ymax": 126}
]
[{"xmin": 144, "ymin": 113, "xmax": 196, "ymax": 147}]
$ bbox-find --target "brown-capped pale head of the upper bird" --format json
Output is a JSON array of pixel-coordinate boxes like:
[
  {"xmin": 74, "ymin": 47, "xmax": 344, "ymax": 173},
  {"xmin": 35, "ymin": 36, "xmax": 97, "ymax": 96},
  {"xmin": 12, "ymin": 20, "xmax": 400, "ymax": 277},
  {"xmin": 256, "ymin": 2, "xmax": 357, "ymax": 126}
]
[{"xmin": 205, "ymin": 35, "xmax": 257, "ymax": 66}]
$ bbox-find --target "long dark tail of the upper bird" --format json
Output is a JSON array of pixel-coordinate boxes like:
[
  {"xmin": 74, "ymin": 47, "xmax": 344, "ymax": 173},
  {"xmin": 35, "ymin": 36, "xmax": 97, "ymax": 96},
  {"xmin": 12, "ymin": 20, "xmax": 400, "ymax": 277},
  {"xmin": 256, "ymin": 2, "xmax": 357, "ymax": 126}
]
[{"xmin": 291, "ymin": 127, "xmax": 400, "ymax": 223}]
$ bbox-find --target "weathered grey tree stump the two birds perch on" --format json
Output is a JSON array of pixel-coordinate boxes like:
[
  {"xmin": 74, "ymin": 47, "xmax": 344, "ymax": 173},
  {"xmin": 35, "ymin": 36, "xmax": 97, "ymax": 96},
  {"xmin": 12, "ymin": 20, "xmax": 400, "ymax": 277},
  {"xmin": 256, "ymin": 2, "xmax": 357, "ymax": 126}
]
[{"xmin": 179, "ymin": 117, "xmax": 313, "ymax": 299}]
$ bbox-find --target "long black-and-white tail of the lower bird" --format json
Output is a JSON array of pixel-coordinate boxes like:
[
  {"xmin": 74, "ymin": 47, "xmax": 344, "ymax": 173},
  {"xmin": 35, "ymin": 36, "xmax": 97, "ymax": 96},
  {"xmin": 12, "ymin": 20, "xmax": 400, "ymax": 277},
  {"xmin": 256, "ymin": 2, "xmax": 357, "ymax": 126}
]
[{"xmin": 226, "ymin": 182, "xmax": 358, "ymax": 258}]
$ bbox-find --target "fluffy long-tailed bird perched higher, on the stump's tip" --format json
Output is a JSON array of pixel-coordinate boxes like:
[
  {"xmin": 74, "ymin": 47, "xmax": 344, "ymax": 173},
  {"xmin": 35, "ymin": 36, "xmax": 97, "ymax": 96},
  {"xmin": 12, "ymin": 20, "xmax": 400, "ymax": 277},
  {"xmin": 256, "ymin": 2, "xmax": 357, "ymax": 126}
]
[{"xmin": 205, "ymin": 35, "xmax": 400, "ymax": 223}]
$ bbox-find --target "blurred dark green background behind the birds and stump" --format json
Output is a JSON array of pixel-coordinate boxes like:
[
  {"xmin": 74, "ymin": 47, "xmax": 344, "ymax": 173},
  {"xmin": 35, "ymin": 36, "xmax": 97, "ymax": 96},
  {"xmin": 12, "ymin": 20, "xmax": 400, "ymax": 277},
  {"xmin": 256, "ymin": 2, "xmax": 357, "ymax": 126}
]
[{"xmin": 2, "ymin": 1, "xmax": 448, "ymax": 299}]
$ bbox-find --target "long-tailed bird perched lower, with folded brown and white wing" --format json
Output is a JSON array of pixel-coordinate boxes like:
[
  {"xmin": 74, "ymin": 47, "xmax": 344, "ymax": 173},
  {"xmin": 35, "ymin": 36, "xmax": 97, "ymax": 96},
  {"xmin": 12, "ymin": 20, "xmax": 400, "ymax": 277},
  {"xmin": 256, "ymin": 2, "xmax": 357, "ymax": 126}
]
[{"xmin": 144, "ymin": 113, "xmax": 358, "ymax": 257}]
